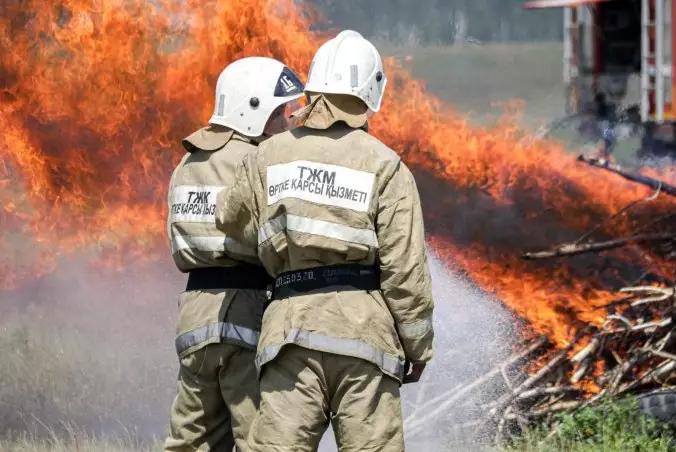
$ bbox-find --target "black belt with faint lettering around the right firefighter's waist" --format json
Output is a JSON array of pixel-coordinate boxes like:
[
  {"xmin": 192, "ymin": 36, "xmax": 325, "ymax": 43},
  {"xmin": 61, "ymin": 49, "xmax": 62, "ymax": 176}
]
[{"xmin": 272, "ymin": 264, "xmax": 380, "ymax": 299}]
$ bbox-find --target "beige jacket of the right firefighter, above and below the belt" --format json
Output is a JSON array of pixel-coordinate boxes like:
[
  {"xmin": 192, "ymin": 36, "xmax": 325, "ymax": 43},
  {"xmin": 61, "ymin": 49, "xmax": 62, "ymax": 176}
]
[{"xmin": 216, "ymin": 96, "xmax": 434, "ymax": 381}]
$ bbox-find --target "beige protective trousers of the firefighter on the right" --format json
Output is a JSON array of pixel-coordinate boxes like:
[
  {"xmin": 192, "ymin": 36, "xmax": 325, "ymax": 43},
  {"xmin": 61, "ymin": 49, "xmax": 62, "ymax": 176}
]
[{"xmin": 249, "ymin": 345, "xmax": 404, "ymax": 452}]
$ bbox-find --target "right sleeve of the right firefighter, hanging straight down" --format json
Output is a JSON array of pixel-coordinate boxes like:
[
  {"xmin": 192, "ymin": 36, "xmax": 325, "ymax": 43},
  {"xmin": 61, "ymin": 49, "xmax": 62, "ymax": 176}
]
[{"xmin": 376, "ymin": 162, "xmax": 434, "ymax": 362}]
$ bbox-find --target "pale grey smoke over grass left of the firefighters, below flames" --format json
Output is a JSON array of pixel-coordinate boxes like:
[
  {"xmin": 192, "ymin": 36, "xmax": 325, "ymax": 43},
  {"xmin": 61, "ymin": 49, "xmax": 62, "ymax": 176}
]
[{"xmin": 0, "ymin": 256, "xmax": 185, "ymax": 439}]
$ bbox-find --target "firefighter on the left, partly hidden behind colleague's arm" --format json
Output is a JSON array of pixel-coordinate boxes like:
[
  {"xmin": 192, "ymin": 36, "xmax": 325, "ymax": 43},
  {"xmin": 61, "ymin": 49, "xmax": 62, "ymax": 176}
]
[{"xmin": 164, "ymin": 57, "xmax": 303, "ymax": 452}]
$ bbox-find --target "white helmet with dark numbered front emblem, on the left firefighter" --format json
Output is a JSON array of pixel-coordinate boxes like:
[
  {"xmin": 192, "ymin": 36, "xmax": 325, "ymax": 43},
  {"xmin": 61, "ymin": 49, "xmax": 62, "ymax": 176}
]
[{"xmin": 209, "ymin": 57, "xmax": 304, "ymax": 137}]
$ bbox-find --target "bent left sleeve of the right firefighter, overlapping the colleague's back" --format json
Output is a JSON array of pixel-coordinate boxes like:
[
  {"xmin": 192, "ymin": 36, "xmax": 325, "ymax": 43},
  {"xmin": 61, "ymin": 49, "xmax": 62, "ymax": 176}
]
[{"xmin": 216, "ymin": 152, "xmax": 258, "ymax": 249}]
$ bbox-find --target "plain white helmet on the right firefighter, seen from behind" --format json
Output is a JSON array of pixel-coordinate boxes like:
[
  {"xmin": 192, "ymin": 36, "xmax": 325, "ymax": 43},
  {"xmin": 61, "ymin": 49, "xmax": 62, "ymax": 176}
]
[{"xmin": 305, "ymin": 30, "xmax": 387, "ymax": 112}]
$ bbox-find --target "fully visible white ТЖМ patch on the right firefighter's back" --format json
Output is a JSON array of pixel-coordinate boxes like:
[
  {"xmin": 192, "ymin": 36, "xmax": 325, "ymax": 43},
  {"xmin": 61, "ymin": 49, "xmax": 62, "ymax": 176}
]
[{"xmin": 267, "ymin": 160, "xmax": 375, "ymax": 212}]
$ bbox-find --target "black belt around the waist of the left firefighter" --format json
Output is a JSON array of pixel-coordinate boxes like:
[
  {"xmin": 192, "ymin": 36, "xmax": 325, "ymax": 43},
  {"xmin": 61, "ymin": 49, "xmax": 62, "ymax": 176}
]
[{"xmin": 185, "ymin": 264, "xmax": 273, "ymax": 290}]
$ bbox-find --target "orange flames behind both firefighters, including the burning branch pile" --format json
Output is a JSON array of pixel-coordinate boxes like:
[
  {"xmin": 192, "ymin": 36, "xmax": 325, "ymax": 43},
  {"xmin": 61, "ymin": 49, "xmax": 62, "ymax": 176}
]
[{"xmin": 0, "ymin": 0, "xmax": 676, "ymax": 442}]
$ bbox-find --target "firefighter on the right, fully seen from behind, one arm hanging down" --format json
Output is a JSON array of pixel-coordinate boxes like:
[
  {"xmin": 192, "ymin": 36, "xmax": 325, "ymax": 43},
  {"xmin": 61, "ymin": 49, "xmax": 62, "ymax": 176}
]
[{"xmin": 216, "ymin": 31, "xmax": 434, "ymax": 452}]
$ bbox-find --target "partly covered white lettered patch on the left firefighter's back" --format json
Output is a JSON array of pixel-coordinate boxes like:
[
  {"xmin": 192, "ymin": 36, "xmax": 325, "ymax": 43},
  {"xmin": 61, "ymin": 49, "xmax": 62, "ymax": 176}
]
[{"xmin": 170, "ymin": 185, "xmax": 225, "ymax": 223}]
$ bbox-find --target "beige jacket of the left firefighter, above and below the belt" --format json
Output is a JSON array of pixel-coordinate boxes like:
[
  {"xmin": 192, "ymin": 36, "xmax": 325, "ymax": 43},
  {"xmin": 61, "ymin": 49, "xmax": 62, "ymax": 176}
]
[{"xmin": 167, "ymin": 126, "xmax": 267, "ymax": 358}]
